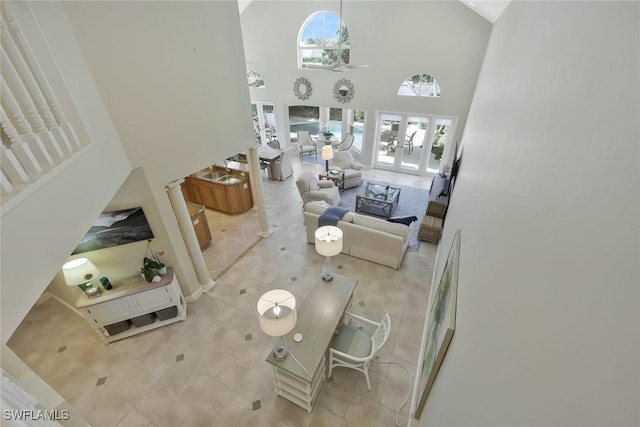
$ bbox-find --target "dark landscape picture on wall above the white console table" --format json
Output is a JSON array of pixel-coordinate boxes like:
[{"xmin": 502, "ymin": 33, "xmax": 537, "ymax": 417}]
[{"xmin": 71, "ymin": 207, "xmax": 153, "ymax": 255}]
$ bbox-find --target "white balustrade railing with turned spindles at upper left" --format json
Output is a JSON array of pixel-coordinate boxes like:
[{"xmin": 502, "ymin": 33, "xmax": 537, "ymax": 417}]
[{"xmin": 0, "ymin": 8, "xmax": 89, "ymax": 205}]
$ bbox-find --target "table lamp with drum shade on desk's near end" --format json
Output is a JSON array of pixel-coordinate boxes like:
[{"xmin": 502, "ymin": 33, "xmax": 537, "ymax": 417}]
[{"xmin": 257, "ymin": 289, "xmax": 297, "ymax": 360}]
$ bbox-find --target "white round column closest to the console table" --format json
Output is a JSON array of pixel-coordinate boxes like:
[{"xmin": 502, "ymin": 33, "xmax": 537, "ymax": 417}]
[{"xmin": 165, "ymin": 178, "xmax": 215, "ymax": 291}]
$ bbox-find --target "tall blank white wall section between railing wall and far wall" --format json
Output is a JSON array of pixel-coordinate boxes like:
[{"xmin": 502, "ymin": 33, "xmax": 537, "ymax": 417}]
[{"xmin": 64, "ymin": 1, "xmax": 255, "ymax": 295}]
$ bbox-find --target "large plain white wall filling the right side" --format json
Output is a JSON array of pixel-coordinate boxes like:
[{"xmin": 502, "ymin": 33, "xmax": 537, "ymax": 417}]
[{"xmin": 414, "ymin": 2, "xmax": 640, "ymax": 427}]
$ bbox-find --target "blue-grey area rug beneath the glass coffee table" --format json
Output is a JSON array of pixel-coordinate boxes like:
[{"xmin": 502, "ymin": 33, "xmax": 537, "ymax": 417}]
[{"xmin": 339, "ymin": 181, "xmax": 429, "ymax": 251}]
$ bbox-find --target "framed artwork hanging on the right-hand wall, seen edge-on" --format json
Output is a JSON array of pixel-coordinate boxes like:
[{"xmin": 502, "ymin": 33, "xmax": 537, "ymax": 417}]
[{"xmin": 415, "ymin": 230, "xmax": 460, "ymax": 419}]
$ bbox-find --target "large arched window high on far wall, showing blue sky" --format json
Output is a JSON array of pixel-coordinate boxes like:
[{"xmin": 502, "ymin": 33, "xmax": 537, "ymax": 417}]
[{"xmin": 298, "ymin": 11, "xmax": 350, "ymax": 68}]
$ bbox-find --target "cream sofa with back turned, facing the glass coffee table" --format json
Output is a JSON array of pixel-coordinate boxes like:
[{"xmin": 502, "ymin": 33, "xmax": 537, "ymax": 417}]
[{"xmin": 304, "ymin": 201, "xmax": 416, "ymax": 270}]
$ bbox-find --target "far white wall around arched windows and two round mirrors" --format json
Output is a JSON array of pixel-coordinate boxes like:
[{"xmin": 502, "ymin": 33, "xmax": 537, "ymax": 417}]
[{"xmin": 241, "ymin": 1, "xmax": 491, "ymax": 163}]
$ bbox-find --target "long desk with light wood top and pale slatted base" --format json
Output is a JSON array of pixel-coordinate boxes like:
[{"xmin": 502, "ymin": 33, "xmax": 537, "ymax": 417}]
[{"xmin": 266, "ymin": 272, "xmax": 358, "ymax": 412}]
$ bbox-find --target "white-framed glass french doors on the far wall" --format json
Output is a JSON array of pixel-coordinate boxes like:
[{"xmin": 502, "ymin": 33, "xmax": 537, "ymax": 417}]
[{"xmin": 374, "ymin": 113, "xmax": 457, "ymax": 175}]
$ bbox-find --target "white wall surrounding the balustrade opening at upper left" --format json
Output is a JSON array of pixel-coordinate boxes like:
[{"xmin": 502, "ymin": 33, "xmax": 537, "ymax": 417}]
[{"xmin": 1, "ymin": 2, "xmax": 130, "ymax": 342}]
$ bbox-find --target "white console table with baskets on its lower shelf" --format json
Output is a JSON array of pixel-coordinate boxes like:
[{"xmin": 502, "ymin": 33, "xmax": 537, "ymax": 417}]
[{"xmin": 76, "ymin": 268, "xmax": 187, "ymax": 343}]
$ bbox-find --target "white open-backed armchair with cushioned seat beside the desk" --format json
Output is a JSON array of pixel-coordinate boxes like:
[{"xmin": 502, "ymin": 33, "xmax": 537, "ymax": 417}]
[{"xmin": 327, "ymin": 312, "xmax": 391, "ymax": 391}]
